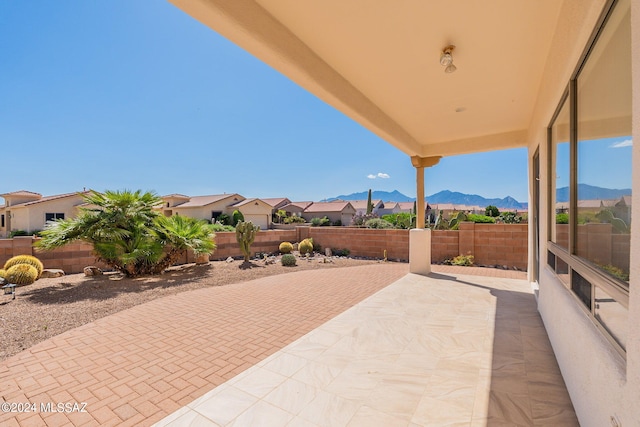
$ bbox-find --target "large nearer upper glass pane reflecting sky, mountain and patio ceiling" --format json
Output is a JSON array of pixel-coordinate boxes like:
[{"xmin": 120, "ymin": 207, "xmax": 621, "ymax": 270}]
[{"xmin": 575, "ymin": 0, "xmax": 633, "ymax": 282}]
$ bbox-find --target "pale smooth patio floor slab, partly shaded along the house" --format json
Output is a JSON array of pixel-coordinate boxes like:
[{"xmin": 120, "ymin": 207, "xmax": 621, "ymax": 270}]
[{"xmin": 155, "ymin": 268, "xmax": 578, "ymax": 427}]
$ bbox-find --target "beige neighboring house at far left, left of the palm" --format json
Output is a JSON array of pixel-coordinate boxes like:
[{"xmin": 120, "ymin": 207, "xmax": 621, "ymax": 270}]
[{"xmin": 0, "ymin": 190, "xmax": 87, "ymax": 237}]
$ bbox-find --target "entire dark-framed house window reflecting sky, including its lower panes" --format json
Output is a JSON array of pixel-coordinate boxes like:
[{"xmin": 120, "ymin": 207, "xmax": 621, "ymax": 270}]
[{"xmin": 547, "ymin": 0, "xmax": 633, "ymax": 354}]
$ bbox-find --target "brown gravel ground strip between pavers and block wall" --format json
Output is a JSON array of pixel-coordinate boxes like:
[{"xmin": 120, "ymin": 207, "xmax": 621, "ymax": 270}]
[{"xmin": 0, "ymin": 257, "xmax": 380, "ymax": 360}]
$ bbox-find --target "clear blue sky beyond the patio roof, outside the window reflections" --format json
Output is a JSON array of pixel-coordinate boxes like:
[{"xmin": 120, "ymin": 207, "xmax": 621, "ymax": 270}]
[{"xmin": 0, "ymin": 0, "xmax": 528, "ymax": 201}]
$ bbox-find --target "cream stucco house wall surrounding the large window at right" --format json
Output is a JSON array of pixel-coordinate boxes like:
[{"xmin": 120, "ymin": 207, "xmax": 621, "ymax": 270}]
[{"xmin": 528, "ymin": 0, "xmax": 640, "ymax": 427}]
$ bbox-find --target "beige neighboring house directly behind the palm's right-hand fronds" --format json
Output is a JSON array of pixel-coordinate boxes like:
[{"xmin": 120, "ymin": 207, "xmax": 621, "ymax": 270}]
[{"xmin": 162, "ymin": 193, "xmax": 246, "ymax": 222}]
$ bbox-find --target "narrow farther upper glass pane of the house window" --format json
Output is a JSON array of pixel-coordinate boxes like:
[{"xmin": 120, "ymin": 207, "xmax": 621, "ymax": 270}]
[{"xmin": 549, "ymin": 101, "xmax": 570, "ymax": 250}]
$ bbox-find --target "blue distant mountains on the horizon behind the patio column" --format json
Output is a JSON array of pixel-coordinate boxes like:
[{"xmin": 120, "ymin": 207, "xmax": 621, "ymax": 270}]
[{"xmin": 327, "ymin": 190, "xmax": 527, "ymax": 209}]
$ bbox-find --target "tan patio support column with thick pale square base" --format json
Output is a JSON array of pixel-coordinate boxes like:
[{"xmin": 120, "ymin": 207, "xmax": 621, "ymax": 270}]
[{"xmin": 409, "ymin": 156, "xmax": 440, "ymax": 275}]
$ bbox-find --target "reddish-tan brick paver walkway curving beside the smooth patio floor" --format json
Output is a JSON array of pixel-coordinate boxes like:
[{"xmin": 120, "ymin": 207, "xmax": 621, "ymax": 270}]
[{"xmin": 0, "ymin": 263, "xmax": 408, "ymax": 427}]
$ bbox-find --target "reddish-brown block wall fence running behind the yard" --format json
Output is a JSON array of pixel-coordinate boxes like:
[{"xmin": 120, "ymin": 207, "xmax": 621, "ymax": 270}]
[{"xmin": 0, "ymin": 223, "xmax": 527, "ymax": 274}]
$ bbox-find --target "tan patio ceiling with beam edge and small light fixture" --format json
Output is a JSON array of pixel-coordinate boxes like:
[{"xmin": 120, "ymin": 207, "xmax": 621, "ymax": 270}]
[{"xmin": 170, "ymin": 0, "xmax": 563, "ymax": 157}]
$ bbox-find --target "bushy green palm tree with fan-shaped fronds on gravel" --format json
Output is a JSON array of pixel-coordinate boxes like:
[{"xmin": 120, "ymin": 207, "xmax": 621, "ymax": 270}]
[{"xmin": 38, "ymin": 190, "xmax": 215, "ymax": 276}]
